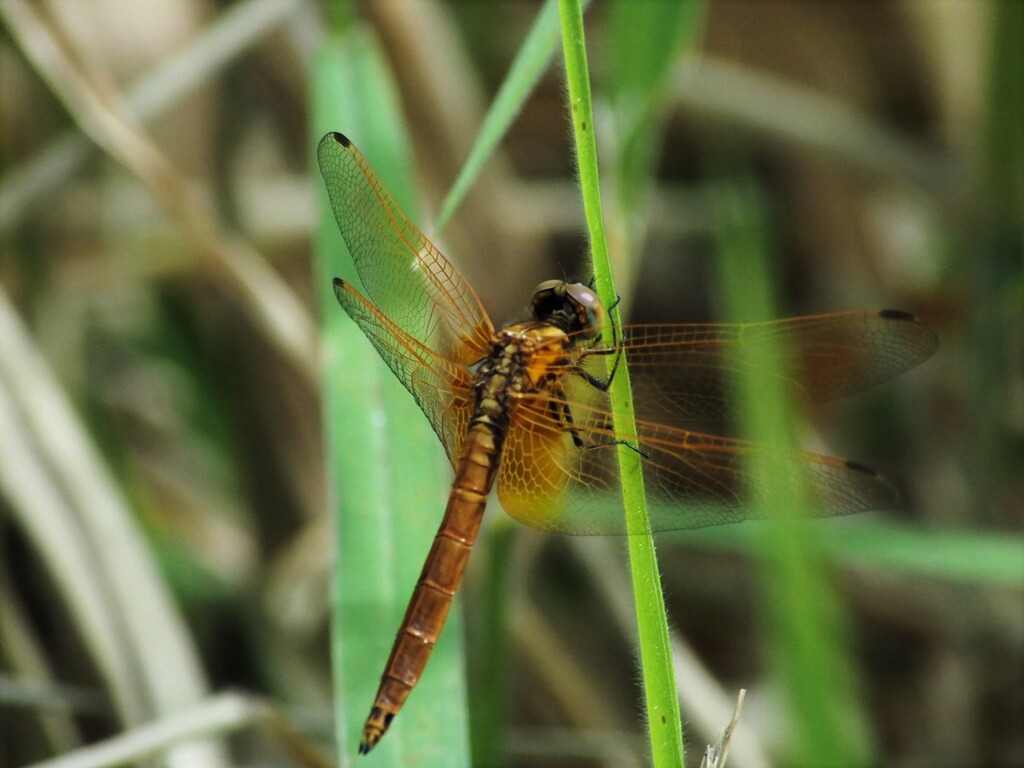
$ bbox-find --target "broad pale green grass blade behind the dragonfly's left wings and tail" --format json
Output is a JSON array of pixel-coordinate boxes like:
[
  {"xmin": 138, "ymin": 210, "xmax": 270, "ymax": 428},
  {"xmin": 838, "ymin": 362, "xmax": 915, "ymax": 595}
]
[{"xmin": 312, "ymin": 29, "xmax": 468, "ymax": 768}]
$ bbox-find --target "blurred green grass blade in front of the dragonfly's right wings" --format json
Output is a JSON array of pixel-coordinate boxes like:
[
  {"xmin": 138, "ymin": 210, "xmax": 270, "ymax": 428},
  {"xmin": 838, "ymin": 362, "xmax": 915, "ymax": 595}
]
[{"xmin": 714, "ymin": 183, "xmax": 873, "ymax": 766}]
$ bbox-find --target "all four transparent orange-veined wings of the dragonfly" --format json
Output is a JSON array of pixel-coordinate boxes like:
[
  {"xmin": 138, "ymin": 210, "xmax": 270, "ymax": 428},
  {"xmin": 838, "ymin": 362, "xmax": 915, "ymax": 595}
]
[{"xmin": 317, "ymin": 133, "xmax": 937, "ymax": 534}]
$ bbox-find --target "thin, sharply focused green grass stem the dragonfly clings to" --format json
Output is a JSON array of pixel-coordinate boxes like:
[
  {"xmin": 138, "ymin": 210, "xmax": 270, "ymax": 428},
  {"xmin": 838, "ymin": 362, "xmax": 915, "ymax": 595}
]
[{"xmin": 559, "ymin": 0, "xmax": 683, "ymax": 766}]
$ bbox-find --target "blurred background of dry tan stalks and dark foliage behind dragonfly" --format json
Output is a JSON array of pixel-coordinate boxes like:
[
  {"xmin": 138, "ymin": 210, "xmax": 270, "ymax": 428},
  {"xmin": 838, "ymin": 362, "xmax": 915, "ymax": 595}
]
[{"xmin": 0, "ymin": 0, "xmax": 1024, "ymax": 766}]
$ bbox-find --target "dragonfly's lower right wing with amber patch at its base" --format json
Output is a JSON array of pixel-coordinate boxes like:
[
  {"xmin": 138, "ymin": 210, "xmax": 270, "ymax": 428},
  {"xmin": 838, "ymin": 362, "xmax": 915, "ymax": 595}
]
[{"xmin": 498, "ymin": 391, "xmax": 899, "ymax": 535}]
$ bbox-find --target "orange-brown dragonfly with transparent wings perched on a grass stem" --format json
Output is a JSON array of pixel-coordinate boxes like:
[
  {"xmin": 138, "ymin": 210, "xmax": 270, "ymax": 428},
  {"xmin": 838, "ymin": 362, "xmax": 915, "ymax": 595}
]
[{"xmin": 317, "ymin": 132, "xmax": 938, "ymax": 754}]
